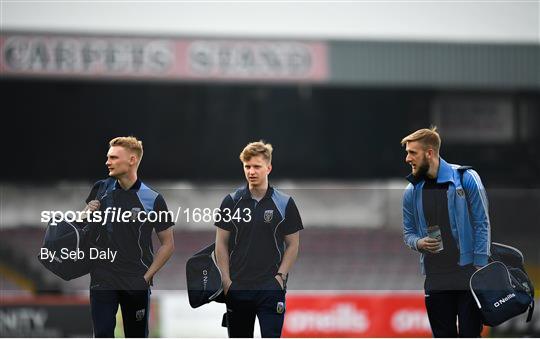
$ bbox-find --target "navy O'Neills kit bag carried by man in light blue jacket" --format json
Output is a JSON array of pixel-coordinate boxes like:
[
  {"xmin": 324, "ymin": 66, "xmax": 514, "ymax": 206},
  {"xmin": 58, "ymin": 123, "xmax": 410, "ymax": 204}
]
[{"xmin": 470, "ymin": 243, "xmax": 534, "ymax": 326}]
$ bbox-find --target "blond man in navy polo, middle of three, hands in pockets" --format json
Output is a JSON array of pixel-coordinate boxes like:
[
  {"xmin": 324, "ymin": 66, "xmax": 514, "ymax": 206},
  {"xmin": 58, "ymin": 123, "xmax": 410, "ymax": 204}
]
[{"xmin": 215, "ymin": 141, "xmax": 303, "ymax": 337}]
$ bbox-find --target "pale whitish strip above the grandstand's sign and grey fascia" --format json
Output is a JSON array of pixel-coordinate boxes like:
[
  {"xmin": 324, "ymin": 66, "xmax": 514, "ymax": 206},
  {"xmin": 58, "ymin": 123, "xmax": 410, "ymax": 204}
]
[{"xmin": 4, "ymin": 1, "xmax": 540, "ymax": 43}]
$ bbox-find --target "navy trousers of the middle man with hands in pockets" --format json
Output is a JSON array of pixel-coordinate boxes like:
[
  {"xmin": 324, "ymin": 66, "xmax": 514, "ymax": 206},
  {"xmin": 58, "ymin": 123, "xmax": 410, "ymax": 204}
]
[{"xmin": 226, "ymin": 277, "xmax": 285, "ymax": 338}]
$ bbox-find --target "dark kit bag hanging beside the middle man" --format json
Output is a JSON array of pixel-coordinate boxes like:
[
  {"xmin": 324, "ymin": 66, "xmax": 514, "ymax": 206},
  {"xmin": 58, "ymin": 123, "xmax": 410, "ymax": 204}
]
[{"xmin": 186, "ymin": 244, "xmax": 224, "ymax": 308}]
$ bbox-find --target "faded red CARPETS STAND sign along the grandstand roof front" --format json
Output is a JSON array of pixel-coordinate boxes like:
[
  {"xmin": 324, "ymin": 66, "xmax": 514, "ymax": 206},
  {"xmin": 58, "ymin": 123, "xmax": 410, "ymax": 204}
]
[{"xmin": 0, "ymin": 34, "xmax": 328, "ymax": 81}]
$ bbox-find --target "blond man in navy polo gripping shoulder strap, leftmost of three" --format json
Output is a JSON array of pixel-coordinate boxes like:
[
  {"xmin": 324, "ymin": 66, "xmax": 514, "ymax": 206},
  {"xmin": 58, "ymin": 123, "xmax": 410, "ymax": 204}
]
[{"xmin": 85, "ymin": 137, "xmax": 174, "ymax": 337}]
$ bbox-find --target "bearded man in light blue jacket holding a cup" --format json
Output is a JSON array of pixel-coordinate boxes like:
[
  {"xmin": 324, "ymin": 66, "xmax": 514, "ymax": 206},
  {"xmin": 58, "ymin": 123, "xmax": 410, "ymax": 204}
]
[{"xmin": 401, "ymin": 128, "xmax": 491, "ymax": 337}]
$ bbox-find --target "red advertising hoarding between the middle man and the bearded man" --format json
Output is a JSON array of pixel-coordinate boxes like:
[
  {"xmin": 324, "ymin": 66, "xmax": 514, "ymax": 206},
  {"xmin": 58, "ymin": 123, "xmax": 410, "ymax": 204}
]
[{"xmin": 283, "ymin": 293, "xmax": 490, "ymax": 337}]
